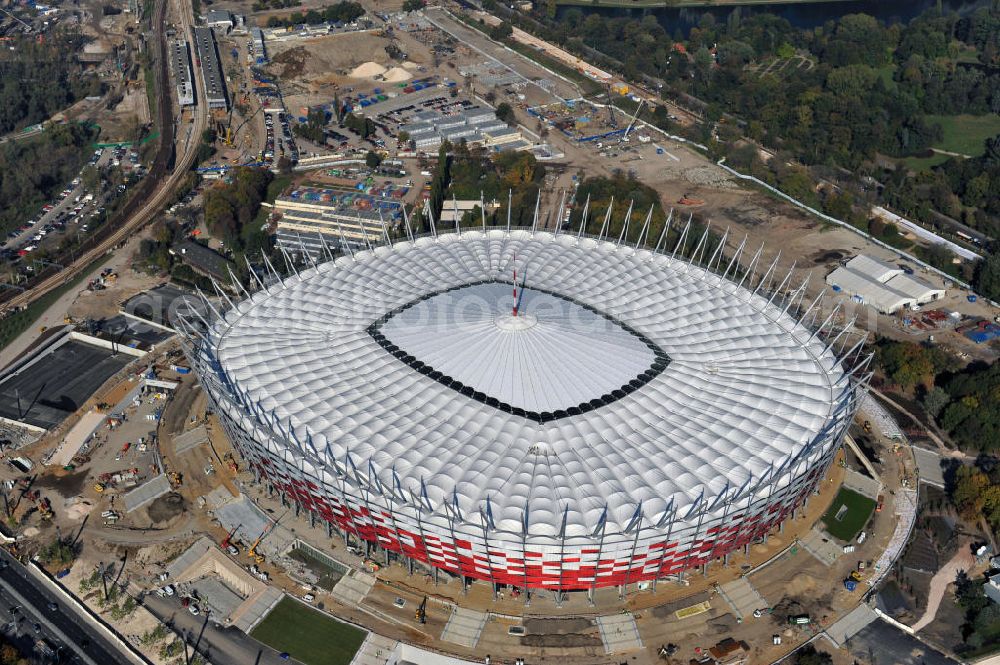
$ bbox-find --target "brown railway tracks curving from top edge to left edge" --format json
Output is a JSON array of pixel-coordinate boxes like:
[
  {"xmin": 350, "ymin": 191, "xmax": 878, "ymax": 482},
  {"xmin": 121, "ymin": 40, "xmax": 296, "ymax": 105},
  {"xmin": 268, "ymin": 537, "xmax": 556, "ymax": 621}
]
[{"xmin": 0, "ymin": 0, "xmax": 205, "ymax": 318}]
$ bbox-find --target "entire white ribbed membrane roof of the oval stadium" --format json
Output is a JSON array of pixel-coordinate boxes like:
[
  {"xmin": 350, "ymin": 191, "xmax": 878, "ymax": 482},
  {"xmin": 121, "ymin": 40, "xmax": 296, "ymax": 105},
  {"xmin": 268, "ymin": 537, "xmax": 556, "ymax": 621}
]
[{"xmin": 211, "ymin": 230, "xmax": 851, "ymax": 536}]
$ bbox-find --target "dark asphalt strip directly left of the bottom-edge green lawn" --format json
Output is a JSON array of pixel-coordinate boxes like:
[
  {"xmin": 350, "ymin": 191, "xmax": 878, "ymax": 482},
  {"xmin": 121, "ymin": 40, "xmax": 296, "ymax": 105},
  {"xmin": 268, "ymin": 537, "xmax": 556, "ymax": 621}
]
[{"xmin": 142, "ymin": 594, "xmax": 298, "ymax": 665}]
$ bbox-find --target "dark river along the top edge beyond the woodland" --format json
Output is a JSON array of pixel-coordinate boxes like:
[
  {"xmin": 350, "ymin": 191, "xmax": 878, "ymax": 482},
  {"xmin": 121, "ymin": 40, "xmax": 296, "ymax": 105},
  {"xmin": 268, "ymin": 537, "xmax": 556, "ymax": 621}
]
[{"xmin": 559, "ymin": 0, "xmax": 989, "ymax": 36}]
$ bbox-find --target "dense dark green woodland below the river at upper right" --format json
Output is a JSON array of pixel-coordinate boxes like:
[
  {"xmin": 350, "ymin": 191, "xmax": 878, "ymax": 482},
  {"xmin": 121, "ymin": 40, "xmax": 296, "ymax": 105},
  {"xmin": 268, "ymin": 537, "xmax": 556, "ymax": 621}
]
[{"xmin": 486, "ymin": 0, "xmax": 1000, "ymax": 298}]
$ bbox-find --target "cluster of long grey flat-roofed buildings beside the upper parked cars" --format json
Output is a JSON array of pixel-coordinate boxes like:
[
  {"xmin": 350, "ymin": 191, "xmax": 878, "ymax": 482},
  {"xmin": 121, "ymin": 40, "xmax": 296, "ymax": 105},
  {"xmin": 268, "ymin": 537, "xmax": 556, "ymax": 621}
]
[{"xmin": 400, "ymin": 106, "xmax": 528, "ymax": 152}]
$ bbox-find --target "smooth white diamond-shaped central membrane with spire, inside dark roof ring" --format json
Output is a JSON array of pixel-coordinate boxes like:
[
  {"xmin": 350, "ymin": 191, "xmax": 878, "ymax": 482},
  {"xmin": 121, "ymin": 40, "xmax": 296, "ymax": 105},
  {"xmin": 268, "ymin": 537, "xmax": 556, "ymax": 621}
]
[{"xmin": 381, "ymin": 282, "xmax": 656, "ymax": 412}]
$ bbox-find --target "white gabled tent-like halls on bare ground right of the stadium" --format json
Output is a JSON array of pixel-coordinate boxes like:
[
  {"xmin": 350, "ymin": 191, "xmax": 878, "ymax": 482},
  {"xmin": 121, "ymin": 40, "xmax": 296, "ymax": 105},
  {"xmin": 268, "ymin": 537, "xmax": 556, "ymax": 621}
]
[{"xmin": 826, "ymin": 254, "xmax": 945, "ymax": 314}]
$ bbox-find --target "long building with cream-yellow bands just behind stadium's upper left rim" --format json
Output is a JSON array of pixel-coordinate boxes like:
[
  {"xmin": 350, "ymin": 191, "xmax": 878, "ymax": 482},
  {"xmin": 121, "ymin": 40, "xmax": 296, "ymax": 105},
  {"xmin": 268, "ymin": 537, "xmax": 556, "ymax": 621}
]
[{"xmin": 274, "ymin": 187, "xmax": 402, "ymax": 258}]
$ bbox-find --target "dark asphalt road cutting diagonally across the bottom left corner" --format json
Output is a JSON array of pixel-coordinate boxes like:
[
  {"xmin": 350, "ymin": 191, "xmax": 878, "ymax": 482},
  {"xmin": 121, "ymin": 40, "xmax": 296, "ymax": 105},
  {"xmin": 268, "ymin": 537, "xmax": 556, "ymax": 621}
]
[{"xmin": 0, "ymin": 550, "xmax": 131, "ymax": 665}]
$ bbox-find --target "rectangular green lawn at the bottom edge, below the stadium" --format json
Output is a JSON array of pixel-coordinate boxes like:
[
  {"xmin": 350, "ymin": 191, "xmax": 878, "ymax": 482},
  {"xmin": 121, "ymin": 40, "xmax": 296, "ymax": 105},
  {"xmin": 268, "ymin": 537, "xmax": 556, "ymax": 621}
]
[{"xmin": 250, "ymin": 596, "xmax": 365, "ymax": 665}]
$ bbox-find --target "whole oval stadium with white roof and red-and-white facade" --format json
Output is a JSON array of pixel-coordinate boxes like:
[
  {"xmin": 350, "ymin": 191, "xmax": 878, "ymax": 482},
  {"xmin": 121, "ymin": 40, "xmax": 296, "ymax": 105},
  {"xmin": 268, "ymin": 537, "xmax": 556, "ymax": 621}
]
[{"xmin": 187, "ymin": 222, "xmax": 862, "ymax": 591}]
